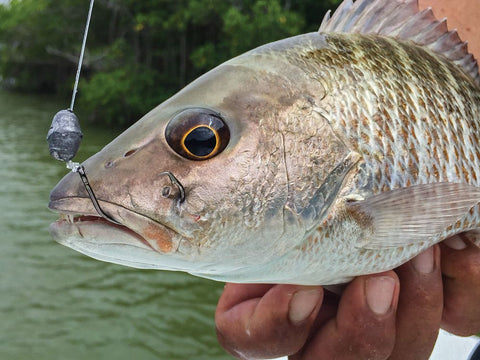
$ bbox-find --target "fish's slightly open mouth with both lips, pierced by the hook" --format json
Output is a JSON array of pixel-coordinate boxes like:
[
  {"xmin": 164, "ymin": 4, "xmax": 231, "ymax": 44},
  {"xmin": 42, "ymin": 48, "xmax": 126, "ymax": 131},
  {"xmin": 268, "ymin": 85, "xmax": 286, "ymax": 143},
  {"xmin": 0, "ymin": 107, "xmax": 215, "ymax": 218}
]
[{"xmin": 48, "ymin": 197, "xmax": 193, "ymax": 270}]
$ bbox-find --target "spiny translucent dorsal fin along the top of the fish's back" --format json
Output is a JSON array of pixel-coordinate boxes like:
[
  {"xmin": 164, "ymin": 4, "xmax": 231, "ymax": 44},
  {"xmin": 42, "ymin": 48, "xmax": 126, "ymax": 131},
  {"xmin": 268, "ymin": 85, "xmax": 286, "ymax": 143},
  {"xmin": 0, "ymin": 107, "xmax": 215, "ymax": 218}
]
[{"xmin": 319, "ymin": 0, "xmax": 480, "ymax": 86}]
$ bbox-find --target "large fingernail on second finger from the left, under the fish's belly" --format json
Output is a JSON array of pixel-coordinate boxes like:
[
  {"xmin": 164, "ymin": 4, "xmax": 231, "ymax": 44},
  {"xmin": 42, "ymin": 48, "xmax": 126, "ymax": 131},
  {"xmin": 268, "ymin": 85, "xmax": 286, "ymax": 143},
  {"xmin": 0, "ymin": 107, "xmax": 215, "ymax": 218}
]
[{"xmin": 365, "ymin": 276, "xmax": 395, "ymax": 315}]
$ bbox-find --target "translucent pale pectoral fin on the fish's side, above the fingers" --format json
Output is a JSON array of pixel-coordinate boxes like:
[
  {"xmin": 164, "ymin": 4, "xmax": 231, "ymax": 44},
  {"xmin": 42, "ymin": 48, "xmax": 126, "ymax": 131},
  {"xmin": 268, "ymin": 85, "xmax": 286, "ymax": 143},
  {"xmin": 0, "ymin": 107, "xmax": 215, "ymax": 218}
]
[{"xmin": 348, "ymin": 183, "xmax": 480, "ymax": 249}]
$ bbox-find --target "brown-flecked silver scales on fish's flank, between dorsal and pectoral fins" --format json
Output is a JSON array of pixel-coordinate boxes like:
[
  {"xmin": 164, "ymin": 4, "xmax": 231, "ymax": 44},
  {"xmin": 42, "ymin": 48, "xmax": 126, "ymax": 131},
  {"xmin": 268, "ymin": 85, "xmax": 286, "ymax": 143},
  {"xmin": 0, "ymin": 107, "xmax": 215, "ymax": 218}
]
[{"xmin": 314, "ymin": 34, "xmax": 480, "ymax": 195}]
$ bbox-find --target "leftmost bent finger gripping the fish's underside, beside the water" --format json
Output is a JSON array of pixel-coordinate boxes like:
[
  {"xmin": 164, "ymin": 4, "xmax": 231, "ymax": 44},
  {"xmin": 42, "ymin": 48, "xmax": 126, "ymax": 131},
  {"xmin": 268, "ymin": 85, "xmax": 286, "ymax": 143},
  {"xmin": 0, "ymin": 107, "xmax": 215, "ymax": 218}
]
[{"xmin": 215, "ymin": 284, "xmax": 323, "ymax": 359}]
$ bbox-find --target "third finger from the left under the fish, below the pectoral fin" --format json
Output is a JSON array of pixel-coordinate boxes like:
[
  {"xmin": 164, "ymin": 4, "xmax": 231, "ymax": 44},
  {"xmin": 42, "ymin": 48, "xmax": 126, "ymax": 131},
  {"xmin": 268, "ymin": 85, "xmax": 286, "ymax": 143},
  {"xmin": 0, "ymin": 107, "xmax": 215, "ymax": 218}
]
[{"xmin": 389, "ymin": 245, "xmax": 443, "ymax": 360}]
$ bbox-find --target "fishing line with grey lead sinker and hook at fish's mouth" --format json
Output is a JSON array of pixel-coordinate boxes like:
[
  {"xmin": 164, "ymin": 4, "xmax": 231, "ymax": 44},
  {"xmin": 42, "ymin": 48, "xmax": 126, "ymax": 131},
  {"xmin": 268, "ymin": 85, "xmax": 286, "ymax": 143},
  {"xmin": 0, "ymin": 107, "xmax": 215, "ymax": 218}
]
[{"xmin": 47, "ymin": 0, "xmax": 119, "ymax": 224}]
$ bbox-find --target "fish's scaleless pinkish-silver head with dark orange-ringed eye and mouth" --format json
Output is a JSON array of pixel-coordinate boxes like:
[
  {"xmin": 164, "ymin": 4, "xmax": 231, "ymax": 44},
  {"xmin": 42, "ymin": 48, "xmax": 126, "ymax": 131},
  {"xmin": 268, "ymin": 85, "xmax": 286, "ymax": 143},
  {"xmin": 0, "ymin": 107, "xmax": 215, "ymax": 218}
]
[{"xmin": 49, "ymin": 34, "xmax": 346, "ymax": 279}]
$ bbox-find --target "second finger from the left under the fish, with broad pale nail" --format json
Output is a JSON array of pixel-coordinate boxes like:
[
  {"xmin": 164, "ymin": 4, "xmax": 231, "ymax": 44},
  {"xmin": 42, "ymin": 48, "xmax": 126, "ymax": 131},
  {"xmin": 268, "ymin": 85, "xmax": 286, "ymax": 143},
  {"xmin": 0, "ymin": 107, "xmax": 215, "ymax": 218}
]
[{"xmin": 291, "ymin": 271, "xmax": 399, "ymax": 360}]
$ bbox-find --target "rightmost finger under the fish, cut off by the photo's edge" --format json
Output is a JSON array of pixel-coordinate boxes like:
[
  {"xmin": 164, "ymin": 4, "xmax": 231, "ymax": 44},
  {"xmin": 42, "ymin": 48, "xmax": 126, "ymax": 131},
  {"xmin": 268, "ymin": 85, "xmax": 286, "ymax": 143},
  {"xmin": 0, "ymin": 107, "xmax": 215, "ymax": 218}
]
[{"xmin": 441, "ymin": 234, "xmax": 480, "ymax": 336}]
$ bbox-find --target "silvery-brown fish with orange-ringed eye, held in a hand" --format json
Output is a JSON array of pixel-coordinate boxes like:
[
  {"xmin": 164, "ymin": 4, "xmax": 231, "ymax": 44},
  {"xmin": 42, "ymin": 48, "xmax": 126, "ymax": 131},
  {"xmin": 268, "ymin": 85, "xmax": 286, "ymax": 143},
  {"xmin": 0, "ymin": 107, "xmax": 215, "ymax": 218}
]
[{"xmin": 49, "ymin": 0, "xmax": 480, "ymax": 285}]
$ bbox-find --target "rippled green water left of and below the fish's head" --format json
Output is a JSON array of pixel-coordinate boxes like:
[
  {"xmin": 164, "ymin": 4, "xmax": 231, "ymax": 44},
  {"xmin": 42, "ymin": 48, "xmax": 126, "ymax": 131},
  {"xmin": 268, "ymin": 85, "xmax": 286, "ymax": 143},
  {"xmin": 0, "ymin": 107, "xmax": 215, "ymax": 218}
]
[{"xmin": 0, "ymin": 92, "xmax": 229, "ymax": 360}]
